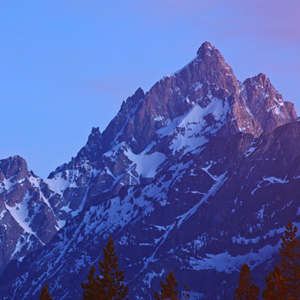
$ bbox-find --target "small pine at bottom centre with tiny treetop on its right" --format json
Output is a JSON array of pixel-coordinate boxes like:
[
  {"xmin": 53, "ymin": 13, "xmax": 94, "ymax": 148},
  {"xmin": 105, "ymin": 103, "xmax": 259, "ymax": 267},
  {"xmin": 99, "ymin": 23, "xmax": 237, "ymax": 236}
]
[{"xmin": 154, "ymin": 270, "xmax": 190, "ymax": 300}]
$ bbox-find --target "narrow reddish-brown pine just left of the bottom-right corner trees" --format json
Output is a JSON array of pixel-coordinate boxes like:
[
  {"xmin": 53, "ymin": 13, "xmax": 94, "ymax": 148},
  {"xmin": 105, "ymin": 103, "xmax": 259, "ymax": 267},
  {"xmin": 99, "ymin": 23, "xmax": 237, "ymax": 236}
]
[{"xmin": 234, "ymin": 264, "xmax": 259, "ymax": 300}]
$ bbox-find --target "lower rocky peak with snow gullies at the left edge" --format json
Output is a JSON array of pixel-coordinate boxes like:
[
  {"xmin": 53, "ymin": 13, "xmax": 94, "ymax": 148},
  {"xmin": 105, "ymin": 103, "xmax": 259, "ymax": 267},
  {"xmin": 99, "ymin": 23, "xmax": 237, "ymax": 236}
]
[{"xmin": 0, "ymin": 156, "xmax": 59, "ymax": 272}]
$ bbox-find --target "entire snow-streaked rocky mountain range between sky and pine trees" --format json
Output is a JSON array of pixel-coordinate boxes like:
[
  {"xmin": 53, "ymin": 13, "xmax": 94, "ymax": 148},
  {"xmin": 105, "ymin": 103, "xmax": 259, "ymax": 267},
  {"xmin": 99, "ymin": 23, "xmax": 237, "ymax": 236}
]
[{"xmin": 0, "ymin": 42, "xmax": 300, "ymax": 299}]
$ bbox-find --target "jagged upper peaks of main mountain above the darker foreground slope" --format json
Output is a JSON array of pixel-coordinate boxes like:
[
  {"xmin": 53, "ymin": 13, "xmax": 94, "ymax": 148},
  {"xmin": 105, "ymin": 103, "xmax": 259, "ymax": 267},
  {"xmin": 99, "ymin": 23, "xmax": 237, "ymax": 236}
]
[{"xmin": 41, "ymin": 42, "xmax": 296, "ymax": 213}]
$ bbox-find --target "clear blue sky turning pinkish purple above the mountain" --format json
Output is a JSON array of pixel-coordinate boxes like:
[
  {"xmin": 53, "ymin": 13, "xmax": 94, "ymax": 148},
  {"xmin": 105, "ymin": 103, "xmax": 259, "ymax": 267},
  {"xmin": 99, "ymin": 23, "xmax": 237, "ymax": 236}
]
[{"xmin": 0, "ymin": 0, "xmax": 300, "ymax": 178}]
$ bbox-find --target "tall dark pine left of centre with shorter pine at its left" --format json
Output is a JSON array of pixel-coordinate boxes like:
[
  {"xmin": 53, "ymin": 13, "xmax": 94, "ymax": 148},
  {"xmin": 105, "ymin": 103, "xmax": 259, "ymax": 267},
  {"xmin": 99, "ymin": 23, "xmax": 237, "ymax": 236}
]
[{"xmin": 82, "ymin": 237, "xmax": 128, "ymax": 300}]
